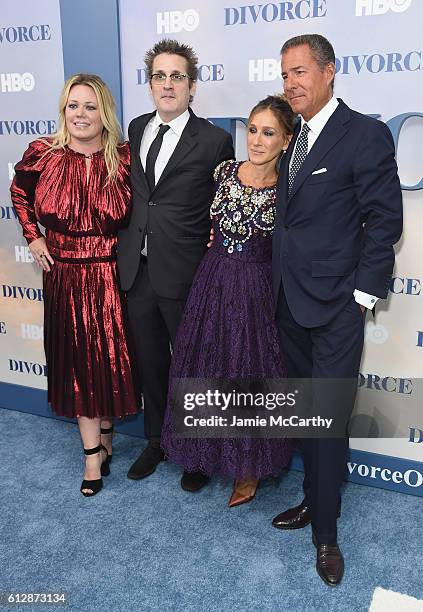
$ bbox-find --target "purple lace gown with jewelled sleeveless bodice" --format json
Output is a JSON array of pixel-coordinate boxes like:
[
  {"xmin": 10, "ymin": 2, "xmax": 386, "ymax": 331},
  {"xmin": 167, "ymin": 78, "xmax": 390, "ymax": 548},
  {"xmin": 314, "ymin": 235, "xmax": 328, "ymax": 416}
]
[{"xmin": 162, "ymin": 161, "xmax": 291, "ymax": 479}]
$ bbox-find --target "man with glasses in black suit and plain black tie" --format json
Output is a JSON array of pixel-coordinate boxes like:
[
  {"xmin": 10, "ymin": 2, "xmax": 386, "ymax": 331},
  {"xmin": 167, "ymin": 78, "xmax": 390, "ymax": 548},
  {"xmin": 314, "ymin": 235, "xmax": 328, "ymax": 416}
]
[{"xmin": 118, "ymin": 39, "xmax": 234, "ymax": 491}]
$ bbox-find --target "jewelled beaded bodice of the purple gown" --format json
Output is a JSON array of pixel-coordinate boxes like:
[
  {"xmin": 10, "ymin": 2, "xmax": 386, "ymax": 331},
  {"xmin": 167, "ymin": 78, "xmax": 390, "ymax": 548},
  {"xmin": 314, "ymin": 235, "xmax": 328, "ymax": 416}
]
[{"xmin": 210, "ymin": 160, "xmax": 276, "ymax": 255}]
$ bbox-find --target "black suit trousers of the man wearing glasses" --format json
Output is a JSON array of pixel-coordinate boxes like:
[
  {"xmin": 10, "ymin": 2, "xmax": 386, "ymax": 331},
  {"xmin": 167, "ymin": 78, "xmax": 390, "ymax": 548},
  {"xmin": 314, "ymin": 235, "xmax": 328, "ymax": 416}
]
[{"xmin": 128, "ymin": 256, "xmax": 185, "ymax": 441}]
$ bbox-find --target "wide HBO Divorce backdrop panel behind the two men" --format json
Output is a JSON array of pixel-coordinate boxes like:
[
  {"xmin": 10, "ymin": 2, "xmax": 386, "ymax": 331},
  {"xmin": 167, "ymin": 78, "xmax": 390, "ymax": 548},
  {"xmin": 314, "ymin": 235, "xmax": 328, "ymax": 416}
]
[{"xmin": 120, "ymin": 0, "xmax": 423, "ymax": 489}]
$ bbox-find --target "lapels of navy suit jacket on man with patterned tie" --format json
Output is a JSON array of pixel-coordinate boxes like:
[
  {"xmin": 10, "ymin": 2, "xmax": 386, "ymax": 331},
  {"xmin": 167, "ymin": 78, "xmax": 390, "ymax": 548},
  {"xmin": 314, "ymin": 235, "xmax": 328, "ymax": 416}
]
[{"xmin": 286, "ymin": 100, "xmax": 350, "ymax": 204}]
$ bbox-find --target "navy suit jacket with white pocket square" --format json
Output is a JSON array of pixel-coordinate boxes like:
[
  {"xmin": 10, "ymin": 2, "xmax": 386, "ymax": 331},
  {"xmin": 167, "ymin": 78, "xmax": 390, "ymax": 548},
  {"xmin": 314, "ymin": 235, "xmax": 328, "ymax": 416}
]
[{"xmin": 272, "ymin": 100, "xmax": 402, "ymax": 328}]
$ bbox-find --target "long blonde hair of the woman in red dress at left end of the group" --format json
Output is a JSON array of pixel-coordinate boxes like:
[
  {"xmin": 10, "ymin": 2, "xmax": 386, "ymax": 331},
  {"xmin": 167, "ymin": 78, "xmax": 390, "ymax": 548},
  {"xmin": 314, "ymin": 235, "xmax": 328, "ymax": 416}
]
[{"xmin": 48, "ymin": 73, "xmax": 122, "ymax": 184}]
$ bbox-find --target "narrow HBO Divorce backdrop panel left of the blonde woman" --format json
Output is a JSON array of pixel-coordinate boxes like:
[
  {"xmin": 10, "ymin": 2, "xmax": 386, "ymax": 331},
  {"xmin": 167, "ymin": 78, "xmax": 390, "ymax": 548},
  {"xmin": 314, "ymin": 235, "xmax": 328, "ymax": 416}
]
[{"xmin": 0, "ymin": 0, "xmax": 63, "ymax": 390}]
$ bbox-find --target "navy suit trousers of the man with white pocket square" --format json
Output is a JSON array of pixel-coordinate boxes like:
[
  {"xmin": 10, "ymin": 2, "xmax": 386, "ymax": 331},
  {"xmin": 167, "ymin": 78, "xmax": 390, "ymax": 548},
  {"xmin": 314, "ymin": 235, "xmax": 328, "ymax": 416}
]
[{"xmin": 276, "ymin": 289, "xmax": 364, "ymax": 544}]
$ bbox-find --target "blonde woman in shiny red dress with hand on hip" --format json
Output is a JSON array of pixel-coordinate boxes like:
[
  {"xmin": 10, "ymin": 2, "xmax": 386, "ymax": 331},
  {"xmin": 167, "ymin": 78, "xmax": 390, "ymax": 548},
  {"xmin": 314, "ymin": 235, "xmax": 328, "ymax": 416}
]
[{"xmin": 11, "ymin": 74, "xmax": 138, "ymax": 496}]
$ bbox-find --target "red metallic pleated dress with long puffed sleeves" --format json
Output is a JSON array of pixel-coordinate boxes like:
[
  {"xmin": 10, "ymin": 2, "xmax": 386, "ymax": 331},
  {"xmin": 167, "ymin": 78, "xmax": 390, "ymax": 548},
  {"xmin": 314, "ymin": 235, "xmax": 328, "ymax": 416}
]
[{"xmin": 11, "ymin": 140, "xmax": 139, "ymax": 418}]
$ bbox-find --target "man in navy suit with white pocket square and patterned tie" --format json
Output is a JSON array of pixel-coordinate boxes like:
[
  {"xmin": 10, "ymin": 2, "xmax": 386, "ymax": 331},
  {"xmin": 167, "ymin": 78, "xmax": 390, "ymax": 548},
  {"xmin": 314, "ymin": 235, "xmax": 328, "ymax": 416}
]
[{"xmin": 273, "ymin": 34, "xmax": 402, "ymax": 585}]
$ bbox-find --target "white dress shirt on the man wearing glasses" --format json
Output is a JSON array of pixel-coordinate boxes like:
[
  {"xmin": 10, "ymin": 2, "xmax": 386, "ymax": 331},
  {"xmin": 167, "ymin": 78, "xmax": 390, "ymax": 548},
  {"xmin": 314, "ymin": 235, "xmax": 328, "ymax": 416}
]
[{"xmin": 140, "ymin": 109, "xmax": 189, "ymax": 256}]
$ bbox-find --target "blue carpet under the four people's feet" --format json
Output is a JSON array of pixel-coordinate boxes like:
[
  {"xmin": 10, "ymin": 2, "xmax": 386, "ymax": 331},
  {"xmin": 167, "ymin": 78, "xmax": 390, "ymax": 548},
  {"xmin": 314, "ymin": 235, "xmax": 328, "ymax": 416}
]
[{"xmin": 0, "ymin": 409, "xmax": 423, "ymax": 612}]
